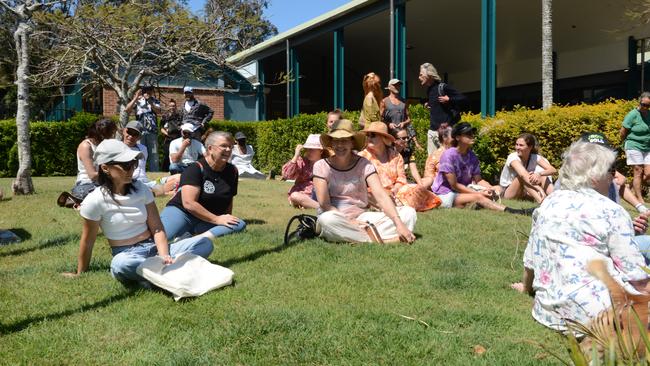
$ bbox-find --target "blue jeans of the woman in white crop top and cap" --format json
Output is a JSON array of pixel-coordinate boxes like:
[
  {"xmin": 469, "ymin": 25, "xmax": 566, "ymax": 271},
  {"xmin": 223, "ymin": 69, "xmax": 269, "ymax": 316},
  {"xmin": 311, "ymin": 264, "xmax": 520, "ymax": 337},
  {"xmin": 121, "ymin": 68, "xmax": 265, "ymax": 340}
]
[{"xmin": 111, "ymin": 237, "xmax": 212, "ymax": 284}]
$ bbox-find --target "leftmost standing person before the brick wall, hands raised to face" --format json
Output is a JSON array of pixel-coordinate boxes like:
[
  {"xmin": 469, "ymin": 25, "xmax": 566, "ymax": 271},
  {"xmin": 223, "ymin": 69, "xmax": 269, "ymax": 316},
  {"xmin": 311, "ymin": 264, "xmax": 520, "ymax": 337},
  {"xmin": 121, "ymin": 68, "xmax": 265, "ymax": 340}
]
[{"xmin": 126, "ymin": 86, "xmax": 160, "ymax": 172}]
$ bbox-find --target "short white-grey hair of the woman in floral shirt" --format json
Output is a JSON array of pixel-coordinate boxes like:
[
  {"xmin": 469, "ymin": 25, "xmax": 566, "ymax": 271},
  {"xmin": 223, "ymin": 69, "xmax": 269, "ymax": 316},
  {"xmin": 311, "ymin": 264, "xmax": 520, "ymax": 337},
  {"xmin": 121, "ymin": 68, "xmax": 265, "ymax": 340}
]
[{"xmin": 558, "ymin": 141, "xmax": 616, "ymax": 190}]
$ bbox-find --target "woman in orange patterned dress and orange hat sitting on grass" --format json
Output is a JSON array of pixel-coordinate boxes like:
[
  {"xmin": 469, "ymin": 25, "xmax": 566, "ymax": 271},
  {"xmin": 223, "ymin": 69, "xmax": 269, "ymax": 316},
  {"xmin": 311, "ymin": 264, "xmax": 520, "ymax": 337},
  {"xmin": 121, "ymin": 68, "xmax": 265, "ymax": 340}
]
[{"xmin": 359, "ymin": 122, "xmax": 440, "ymax": 211}]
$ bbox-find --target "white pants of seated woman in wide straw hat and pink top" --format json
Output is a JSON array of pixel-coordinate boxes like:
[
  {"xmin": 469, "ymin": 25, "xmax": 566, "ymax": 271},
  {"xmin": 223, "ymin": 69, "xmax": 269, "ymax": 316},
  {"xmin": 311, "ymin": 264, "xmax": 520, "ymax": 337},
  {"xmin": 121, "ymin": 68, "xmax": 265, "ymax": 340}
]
[{"xmin": 317, "ymin": 206, "xmax": 418, "ymax": 243}]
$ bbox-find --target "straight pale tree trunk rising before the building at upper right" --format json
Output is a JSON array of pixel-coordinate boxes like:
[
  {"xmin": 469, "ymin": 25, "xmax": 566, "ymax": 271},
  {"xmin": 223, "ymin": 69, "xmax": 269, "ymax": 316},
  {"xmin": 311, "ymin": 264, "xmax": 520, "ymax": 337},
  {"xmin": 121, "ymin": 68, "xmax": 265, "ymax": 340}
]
[{"xmin": 542, "ymin": 0, "xmax": 553, "ymax": 111}]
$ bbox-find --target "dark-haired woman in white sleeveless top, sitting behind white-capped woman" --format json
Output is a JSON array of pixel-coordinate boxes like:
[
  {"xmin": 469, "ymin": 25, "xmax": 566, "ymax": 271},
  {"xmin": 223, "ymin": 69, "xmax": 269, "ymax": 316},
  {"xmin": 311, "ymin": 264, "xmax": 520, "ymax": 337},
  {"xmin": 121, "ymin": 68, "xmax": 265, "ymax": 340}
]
[{"xmin": 71, "ymin": 118, "xmax": 117, "ymax": 200}]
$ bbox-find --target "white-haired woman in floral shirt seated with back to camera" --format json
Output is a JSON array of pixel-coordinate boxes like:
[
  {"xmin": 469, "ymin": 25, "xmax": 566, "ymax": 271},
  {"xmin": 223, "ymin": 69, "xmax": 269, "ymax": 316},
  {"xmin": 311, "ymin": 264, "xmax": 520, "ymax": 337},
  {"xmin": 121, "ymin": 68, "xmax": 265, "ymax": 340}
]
[{"xmin": 512, "ymin": 141, "xmax": 648, "ymax": 331}]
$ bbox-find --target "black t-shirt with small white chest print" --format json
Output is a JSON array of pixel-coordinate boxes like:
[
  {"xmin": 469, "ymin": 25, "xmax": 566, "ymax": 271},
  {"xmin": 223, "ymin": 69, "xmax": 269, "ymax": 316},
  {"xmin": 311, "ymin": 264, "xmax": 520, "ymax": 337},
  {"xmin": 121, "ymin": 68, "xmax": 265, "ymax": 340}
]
[{"xmin": 167, "ymin": 158, "xmax": 239, "ymax": 215}]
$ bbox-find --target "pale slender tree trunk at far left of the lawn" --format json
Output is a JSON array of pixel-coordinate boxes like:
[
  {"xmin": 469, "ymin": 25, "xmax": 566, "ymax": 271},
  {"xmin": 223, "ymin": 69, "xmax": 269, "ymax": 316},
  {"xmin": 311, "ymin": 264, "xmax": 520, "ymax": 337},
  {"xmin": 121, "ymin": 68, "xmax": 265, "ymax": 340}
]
[{"xmin": 11, "ymin": 19, "xmax": 34, "ymax": 194}]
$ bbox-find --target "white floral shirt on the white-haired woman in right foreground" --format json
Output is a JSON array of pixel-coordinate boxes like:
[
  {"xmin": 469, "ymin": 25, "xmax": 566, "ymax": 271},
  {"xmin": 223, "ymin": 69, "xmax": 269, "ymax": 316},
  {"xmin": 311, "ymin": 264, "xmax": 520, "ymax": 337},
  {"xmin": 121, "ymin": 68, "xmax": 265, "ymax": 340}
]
[{"xmin": 524, "ymin": 189, "xmax": 647, "ymax": 331}]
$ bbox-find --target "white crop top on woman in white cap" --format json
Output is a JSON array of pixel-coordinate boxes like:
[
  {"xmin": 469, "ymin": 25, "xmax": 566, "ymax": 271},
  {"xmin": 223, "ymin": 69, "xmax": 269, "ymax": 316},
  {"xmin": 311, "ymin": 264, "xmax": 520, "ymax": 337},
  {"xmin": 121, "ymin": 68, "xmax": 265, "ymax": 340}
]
[{"xmin": 79, "ymin": 181, "xmax": 153, "ymax": 240}]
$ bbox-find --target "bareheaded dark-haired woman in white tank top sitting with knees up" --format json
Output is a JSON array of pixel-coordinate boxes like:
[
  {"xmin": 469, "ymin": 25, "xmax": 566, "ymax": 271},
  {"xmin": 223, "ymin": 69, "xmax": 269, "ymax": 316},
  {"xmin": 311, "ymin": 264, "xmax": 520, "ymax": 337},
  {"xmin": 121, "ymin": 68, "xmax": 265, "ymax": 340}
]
[{"xmin": 499, "ymin": 133, "xmax": 557, "ymax": 203}]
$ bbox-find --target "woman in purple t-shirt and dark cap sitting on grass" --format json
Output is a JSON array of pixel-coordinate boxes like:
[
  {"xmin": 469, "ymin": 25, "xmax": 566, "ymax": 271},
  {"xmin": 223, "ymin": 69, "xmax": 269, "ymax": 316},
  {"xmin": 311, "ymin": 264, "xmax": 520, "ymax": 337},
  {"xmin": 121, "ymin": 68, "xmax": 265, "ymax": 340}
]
[{"xmin": 431, "ymin": 122, "xmax": 531, "ymax": 215}]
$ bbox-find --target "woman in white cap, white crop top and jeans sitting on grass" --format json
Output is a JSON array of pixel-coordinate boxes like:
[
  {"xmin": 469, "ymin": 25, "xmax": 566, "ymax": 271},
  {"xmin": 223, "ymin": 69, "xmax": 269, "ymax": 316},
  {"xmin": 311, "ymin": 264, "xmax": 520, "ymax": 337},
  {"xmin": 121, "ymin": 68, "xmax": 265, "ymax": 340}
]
[{"xmin": 64, "ymin": 139, "xmax": 212, "ymax": 287}]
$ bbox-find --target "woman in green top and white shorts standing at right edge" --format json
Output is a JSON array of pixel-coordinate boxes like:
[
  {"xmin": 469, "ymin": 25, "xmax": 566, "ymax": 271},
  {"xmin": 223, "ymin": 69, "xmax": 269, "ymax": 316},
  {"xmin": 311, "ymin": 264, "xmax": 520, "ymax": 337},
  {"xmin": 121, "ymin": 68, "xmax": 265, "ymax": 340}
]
[{"xmin": 621, "ymin": 92, "xmax": 650, "ymax": 202}]
